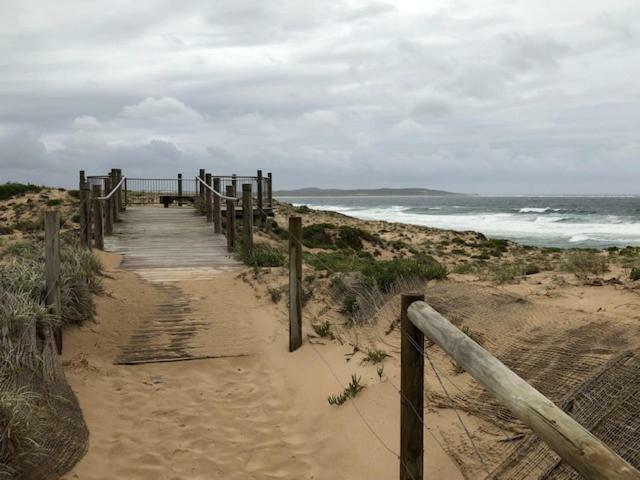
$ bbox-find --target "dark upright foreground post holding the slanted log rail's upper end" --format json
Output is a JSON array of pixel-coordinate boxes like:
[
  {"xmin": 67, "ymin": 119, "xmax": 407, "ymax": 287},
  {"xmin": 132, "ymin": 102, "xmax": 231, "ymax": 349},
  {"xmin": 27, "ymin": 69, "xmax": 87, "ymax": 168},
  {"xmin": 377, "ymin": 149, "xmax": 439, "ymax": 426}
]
[{"xmin": 400, "ymin": 294, "xmax": 424, "ymax": 480}]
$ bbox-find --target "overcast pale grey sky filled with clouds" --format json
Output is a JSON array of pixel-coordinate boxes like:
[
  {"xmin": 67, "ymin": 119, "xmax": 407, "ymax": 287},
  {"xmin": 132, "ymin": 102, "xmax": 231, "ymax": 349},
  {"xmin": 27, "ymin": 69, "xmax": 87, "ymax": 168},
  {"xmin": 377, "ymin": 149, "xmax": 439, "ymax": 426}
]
[{"xmin": 0, "ymin": 0, "xmax": 640, "ymax": 194}]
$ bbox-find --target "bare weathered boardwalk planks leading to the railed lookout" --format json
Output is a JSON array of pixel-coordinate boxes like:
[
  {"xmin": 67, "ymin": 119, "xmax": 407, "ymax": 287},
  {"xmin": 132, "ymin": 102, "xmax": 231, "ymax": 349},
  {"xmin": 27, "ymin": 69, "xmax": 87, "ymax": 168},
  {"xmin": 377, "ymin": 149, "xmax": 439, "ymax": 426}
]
[{"xmin": 104, "ymin": 205, "xmax": 242, "ymax": 282}]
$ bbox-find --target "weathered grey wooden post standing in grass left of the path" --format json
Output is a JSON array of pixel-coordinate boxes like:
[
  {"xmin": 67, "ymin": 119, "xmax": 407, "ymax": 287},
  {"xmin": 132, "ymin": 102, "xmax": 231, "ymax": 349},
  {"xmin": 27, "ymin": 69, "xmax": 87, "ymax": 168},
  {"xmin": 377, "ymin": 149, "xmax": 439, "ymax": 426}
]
[{"xmin": 44, "ymin": 210, "xmax": 62, "ymax": 353}]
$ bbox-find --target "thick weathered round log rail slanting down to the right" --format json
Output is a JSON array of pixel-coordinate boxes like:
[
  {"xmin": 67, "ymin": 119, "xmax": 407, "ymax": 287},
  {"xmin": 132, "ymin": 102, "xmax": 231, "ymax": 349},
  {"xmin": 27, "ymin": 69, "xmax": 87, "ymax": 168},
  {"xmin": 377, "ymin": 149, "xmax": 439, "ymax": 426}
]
[{"xmin": 407, "ymin": 302, "xmax": 640, "ymax": 480}]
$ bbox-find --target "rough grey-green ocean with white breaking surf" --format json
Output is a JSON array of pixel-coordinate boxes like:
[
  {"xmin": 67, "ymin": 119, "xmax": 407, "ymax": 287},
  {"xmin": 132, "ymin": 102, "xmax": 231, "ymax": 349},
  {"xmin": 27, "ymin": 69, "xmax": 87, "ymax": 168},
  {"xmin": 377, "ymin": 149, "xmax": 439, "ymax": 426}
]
[{"xmin": 278, "ymin": 196, "xmax": 640, "ymax": 248}]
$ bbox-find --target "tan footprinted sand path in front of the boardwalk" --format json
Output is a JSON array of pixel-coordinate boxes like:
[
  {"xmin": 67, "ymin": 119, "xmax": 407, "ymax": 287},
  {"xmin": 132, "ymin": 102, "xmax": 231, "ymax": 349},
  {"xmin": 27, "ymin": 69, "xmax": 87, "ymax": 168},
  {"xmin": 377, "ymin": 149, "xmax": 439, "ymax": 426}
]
[{"xmin": 64, "ymin": 255, "xmax": 462, "ymax": 480}]
